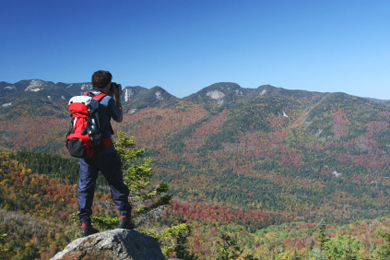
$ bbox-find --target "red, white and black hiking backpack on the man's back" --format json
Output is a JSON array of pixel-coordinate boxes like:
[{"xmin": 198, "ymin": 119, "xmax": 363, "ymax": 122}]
[{"xmin": 66, "ymin": 92, "xmax": 112, "ymax": 159}]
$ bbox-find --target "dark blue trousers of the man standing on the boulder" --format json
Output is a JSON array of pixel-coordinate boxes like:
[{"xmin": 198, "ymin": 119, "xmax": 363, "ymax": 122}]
[{"xmin": 77, "ymin": 151, "xmax": 131, "ymax": 224}]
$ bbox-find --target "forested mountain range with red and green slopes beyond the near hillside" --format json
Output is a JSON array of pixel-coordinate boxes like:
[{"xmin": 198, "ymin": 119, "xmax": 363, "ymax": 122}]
[{"xmin": 0, "ymin": 80, "xmax": 390, "ymax": 226}]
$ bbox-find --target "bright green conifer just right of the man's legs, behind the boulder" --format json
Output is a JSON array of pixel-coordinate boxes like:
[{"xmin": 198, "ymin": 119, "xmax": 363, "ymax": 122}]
[{"xmin": 91, "ymin": 132, "xmax": 197, "ymax": 259}]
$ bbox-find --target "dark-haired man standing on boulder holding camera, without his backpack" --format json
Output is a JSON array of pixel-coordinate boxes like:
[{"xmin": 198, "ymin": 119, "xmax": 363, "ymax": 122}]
[{"xmin": 77, "ymin": 70, "xmax": 134, "ymax": 237}]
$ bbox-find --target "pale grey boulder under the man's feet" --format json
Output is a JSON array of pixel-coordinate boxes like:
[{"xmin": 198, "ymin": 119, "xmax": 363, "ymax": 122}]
[{"xmin": 51, "ymin": 229, "xmax": 164, "ymax": 260}]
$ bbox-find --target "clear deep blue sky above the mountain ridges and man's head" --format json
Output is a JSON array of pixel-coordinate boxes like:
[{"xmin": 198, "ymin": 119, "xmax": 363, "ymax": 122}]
[{"xmin": 0, "ymin": 0, "xmax": 390, "ymax": 99}]
